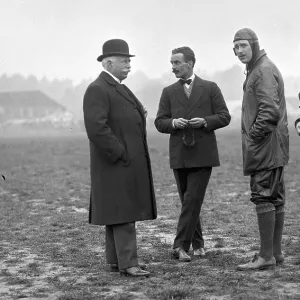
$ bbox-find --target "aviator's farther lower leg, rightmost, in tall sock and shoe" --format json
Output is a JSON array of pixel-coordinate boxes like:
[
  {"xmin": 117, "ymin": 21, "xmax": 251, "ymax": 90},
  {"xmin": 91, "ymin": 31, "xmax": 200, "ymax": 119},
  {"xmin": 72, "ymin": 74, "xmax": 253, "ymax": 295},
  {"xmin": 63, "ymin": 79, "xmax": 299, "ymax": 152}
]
[{"xmin": 273, "ymin": 205, "xmax": 284, "ymax": 264}]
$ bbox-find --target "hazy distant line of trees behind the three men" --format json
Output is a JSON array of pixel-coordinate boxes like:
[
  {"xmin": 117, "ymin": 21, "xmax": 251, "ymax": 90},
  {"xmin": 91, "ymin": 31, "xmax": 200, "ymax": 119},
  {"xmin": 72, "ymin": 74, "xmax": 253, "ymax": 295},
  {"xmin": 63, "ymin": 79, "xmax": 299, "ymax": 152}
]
[{"xmin": 0, "ymin": 65, "xmax": 300, "ymax": 119}]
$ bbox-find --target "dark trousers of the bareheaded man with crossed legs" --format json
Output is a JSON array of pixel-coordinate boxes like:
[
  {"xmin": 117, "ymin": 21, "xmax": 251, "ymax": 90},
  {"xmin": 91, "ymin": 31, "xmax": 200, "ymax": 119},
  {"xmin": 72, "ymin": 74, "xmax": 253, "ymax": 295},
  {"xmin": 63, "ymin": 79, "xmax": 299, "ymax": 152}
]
[{"xmin": 173, "ymin": 167, "xmax": 212, "ymax": 251}]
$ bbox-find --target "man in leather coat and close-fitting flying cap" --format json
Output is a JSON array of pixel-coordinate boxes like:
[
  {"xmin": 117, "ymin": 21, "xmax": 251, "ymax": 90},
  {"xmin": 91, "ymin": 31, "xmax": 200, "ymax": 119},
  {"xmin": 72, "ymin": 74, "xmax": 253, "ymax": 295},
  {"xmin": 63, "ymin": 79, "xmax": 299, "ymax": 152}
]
[{"xmin": 233, "ymin": 28, "xmax": 289, "ymax": 270}]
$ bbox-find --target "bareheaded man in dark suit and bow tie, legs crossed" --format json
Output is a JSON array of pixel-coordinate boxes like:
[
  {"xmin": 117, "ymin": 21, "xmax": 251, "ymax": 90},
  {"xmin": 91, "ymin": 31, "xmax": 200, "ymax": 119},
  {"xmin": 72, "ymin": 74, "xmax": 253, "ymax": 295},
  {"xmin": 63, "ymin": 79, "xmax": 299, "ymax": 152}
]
[{"xmin": 155, "ymin": 47, "xmax": 230, "ymax": 262}]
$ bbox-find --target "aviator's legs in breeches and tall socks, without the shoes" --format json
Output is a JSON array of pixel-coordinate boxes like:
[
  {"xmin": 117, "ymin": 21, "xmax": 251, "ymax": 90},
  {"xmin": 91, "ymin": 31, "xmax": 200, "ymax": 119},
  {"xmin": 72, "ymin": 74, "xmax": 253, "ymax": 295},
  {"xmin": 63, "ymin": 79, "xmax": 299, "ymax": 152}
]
[{"xmin": 250, "ymin": 167, "xmax": 285, "ymax": 258}]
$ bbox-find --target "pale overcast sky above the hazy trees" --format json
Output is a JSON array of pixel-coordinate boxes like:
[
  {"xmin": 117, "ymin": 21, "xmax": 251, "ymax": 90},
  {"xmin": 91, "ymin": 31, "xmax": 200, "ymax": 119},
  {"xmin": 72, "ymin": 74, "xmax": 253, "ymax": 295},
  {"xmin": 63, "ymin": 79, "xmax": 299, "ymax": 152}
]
[{"xmin": 0, "ymin": 0, "xmax": 300, "ymax": 82}]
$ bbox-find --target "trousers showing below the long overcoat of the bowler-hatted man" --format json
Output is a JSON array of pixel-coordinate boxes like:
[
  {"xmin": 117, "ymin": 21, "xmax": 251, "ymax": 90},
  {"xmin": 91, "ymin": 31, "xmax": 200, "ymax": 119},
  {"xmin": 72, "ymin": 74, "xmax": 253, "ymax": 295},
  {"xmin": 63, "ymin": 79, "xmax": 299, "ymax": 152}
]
[{"xmin": 105, "ymin": 222, "xmax": 138, "ymax": 270}]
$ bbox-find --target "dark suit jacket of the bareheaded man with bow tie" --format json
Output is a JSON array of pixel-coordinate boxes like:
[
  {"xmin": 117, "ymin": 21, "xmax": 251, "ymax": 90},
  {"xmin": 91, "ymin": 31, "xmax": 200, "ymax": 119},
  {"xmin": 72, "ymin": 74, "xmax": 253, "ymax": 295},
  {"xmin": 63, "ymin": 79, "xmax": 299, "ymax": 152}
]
[{"xmin": 155, "ymin": 76, "xmax": 231, "ymax": 169}]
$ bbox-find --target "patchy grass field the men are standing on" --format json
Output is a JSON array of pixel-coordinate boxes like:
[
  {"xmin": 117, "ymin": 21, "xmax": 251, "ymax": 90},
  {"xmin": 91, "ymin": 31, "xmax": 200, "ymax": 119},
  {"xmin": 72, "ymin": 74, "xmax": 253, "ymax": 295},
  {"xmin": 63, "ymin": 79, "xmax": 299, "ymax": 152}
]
[{"xmin": 0, "ymin": 131, "xmax": 300, "ymax": 300}]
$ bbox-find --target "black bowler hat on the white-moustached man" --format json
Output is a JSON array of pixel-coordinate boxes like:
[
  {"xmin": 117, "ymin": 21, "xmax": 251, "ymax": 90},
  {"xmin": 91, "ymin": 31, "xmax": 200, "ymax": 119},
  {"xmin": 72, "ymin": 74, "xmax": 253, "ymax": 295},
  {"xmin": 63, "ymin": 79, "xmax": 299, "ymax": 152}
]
[{"xmin": 97, "ymin": 39, "xmax": 135, "ymax": 61}]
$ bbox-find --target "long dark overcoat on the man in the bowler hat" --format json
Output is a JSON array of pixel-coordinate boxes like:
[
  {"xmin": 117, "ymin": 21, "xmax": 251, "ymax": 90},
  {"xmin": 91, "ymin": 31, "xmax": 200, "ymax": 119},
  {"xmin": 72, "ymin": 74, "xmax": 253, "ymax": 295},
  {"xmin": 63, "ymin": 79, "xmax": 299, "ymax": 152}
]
[{"xmin": 83, "ymin": 72, "xmax": 157, "ymax": 225}]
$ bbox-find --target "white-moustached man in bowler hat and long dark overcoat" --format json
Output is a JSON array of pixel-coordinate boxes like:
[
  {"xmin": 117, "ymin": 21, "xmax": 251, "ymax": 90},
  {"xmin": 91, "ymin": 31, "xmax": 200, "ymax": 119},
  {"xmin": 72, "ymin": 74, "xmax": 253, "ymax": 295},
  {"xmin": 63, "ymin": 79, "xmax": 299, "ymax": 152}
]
[{"xmin": 83, "ymin": 39, "xmax": 157, "ymax": 276}]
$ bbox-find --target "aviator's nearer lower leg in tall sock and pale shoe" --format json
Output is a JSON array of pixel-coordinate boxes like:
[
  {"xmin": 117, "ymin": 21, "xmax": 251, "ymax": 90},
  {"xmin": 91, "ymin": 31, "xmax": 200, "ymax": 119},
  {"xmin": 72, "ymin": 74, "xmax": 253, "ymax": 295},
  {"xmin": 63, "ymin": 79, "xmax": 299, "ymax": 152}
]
[{"xmin": 237, "ymin": 203, "xmax": 276, "ymax": 271}]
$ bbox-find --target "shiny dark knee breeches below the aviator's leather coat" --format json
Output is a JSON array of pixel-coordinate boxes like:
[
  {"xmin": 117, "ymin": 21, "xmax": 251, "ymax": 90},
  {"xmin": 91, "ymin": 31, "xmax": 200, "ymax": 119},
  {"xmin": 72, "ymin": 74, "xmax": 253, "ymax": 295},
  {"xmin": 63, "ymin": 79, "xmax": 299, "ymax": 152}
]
[{"xmin": 250, "ymin": 167, "xmax": 285, "ymax": 207}]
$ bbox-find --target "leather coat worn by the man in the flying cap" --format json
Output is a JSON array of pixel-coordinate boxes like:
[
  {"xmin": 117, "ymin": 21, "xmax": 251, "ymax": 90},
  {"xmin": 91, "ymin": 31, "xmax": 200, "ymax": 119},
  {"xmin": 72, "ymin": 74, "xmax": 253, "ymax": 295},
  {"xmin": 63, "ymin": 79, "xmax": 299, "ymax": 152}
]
[{"xmin": 242, "ymin": 50, "xmax": 289, "ymax": 175}]
